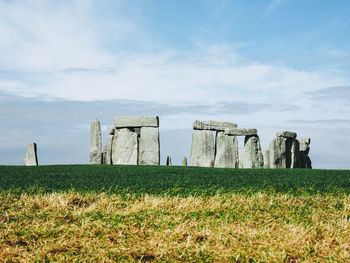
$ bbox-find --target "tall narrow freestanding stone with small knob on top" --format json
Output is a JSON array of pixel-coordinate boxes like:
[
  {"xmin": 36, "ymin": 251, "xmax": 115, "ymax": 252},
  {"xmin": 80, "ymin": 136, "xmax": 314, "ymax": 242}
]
[{"xmin": 90, "ymin": 119, "xmax": 102, "ymax": 164}]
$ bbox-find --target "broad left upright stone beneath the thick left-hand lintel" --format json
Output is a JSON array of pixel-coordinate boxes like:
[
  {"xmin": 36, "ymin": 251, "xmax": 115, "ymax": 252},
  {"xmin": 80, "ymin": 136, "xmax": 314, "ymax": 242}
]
[{"xmin": 112, "ymin": 128, "xmax": 138, "ymax": 165}]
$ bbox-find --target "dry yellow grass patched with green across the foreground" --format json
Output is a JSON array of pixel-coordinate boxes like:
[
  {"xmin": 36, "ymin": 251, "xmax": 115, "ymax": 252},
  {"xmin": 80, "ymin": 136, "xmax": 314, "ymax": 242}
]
[{"xmin": 0, "ymin": 192, "xmax": 350, "ymax": 262}]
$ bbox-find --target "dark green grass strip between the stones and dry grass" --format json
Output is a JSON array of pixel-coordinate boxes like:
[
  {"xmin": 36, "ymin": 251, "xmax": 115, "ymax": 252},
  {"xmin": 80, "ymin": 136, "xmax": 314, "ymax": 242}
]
[{"xmin": 0, "ymin": 165, "xmax": 350, "ymax": 196}]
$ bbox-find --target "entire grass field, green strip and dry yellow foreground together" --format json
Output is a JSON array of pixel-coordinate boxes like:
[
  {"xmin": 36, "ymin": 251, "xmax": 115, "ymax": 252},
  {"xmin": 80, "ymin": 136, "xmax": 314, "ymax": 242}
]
[{"xmin": 0, "ymin": 165, "xmax": 350, "ymax": 262}]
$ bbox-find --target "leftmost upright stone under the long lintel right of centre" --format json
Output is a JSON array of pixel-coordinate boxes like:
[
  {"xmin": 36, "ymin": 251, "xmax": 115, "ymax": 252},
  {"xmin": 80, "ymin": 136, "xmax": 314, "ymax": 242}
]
[{"xmin": 190, "ymin": 130, "xmax": 215, "ymax": 167}]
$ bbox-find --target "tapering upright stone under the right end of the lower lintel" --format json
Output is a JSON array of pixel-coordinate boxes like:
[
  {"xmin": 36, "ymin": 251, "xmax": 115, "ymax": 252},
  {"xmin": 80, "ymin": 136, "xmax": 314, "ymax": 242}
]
[{"xmin": 242, "ymin": 135, "xmax": 264, "ymax": 168}]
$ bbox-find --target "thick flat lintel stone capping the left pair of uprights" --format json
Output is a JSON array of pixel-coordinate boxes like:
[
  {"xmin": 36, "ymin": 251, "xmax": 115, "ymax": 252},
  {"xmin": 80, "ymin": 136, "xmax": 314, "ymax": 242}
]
[{"xmin": 114, "ymin": 116, "xmax": 159, "ymax": 129}]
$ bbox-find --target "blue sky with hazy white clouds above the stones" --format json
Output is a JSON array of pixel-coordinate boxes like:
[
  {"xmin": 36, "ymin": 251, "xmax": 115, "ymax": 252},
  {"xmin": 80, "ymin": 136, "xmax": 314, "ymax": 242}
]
[{"xmin": 0, "ymin": 0, "xmax": 350, "ymax": 169}]
